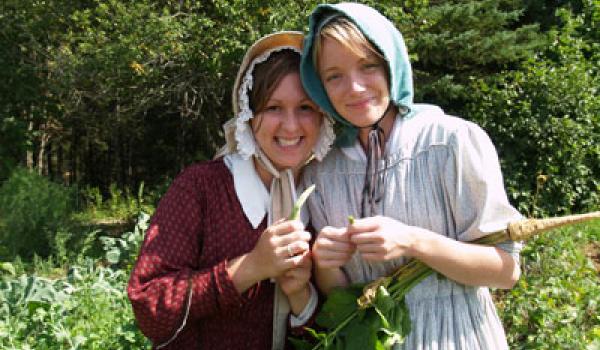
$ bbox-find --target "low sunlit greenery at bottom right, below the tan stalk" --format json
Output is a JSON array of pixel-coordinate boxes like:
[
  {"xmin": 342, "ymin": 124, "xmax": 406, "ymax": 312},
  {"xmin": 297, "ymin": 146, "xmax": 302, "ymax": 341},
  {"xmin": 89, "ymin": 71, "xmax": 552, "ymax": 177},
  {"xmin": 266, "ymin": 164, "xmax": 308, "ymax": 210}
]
[{"xmin": 495, "ymin": 221, "xmax": 600, "ymax": 350}]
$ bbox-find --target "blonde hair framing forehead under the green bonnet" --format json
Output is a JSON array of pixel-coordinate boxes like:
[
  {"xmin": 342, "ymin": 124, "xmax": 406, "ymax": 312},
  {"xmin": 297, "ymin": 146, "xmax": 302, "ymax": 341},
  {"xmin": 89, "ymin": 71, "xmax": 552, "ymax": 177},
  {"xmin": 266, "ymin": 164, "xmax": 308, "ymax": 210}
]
[{"xmin": 313, "ymin": 16, "xmax": 389, "ymax": 76}]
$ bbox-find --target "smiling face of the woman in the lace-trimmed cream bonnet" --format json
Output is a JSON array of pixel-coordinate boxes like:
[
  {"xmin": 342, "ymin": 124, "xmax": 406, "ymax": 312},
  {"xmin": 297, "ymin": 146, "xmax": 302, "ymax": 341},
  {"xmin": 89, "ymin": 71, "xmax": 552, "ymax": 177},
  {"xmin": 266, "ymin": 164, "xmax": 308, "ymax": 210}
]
[{"xmin": 250, "ymin": 73, "xmax": 323, "ymax": 170}]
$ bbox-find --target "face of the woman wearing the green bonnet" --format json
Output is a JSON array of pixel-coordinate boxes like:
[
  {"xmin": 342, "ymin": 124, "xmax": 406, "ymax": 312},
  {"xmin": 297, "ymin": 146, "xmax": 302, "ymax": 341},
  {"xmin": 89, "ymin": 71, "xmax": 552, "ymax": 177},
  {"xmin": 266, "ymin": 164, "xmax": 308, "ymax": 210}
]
[{"xmin": 318, "ymin": 37, "xmax": 390, "ymax": 127}]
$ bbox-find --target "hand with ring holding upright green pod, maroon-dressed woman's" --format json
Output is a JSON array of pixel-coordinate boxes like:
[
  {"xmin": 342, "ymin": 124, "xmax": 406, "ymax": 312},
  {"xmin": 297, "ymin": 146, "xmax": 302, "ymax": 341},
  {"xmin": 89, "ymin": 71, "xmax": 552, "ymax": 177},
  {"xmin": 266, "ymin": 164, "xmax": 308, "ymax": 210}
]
[{"xmin": 248, "ymin": 219, "xmax": 311, "ymax": 280}]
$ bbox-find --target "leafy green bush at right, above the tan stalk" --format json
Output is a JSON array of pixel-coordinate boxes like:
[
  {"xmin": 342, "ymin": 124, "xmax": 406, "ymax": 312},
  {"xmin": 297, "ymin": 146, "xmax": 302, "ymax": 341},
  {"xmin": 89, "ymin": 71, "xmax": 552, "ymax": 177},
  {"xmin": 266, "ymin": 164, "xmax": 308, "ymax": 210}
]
[{"xmin": 466, "ymin": 22, "xmax": 600, "ymax": 216}]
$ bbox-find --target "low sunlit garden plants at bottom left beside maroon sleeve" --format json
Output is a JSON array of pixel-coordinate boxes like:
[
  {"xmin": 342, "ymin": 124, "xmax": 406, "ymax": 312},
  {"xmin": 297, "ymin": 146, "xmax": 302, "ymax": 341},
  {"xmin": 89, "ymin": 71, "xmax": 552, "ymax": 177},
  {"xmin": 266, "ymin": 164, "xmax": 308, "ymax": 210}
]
[{"xmin": 0, "ymin": 216, "xmax": 149, "ymax": 349}]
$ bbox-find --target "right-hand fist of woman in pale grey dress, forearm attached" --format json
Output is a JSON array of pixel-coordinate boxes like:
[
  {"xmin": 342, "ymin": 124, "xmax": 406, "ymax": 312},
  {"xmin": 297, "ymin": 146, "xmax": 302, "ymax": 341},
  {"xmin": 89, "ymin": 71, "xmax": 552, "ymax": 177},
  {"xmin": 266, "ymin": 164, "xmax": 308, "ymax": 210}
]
[{"xmin": 348, "ymin": 216, "xmax": 418, "ymax": 261}]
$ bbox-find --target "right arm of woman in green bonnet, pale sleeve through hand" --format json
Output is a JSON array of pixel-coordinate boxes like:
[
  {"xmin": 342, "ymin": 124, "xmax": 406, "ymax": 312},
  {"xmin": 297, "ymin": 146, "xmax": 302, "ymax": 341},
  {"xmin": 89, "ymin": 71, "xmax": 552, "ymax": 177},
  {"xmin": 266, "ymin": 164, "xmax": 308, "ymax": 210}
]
[{"xmin": 349, "ymin": 124, "xmax": 520, "ymax": 288}]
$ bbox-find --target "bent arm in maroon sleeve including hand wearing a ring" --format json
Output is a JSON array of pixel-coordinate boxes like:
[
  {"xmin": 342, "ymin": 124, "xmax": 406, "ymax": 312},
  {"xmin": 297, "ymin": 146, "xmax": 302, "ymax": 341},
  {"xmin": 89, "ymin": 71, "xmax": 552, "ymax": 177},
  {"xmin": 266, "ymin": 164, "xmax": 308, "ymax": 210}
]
[{"xmin": 128, "ymin": 168, "xmax": 310, "ymax": 343}]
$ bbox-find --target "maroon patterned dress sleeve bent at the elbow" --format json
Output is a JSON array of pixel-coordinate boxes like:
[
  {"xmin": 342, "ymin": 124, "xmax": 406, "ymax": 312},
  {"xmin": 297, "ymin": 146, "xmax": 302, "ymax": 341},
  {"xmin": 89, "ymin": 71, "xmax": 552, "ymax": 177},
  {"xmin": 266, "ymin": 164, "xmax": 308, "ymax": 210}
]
[{"xmin": 127, "ymin": 165, "xmax": 248, "ymax": 344}]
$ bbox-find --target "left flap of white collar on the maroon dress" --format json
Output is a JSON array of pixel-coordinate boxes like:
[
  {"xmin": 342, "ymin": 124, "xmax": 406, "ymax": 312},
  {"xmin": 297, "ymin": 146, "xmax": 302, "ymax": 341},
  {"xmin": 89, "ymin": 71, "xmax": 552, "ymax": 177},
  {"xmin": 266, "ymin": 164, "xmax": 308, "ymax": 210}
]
[{"xmin": 223, "ymin": 153, "xmax": 271, "ymax": 229}]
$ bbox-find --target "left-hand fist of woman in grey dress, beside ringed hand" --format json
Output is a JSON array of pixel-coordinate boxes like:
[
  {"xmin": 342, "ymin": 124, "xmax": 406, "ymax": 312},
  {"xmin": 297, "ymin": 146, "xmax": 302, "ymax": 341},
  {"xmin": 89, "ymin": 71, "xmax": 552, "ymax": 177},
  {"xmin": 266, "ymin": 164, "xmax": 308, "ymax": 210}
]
[{"xmin": 312, "ymin": 226, "xmax": 356, "ymax": 269}]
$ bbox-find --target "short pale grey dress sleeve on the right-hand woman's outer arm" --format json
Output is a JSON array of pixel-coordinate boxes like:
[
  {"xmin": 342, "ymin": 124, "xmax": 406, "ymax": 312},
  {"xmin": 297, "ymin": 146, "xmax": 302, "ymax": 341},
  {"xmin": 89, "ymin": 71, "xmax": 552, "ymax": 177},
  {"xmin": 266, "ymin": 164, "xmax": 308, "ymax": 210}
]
[{"xmin": 444, "ymin": 122, "xmax": 522, "ymax": 261}]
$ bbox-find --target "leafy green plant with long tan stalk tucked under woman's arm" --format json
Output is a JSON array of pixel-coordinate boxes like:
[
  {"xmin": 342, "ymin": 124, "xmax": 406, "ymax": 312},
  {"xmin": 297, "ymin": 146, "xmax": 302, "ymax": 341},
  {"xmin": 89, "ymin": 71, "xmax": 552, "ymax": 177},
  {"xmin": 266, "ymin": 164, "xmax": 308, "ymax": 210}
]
[{"xmin": 293, "ymin": 211, "xmax": 600, "ymax": 350}]
